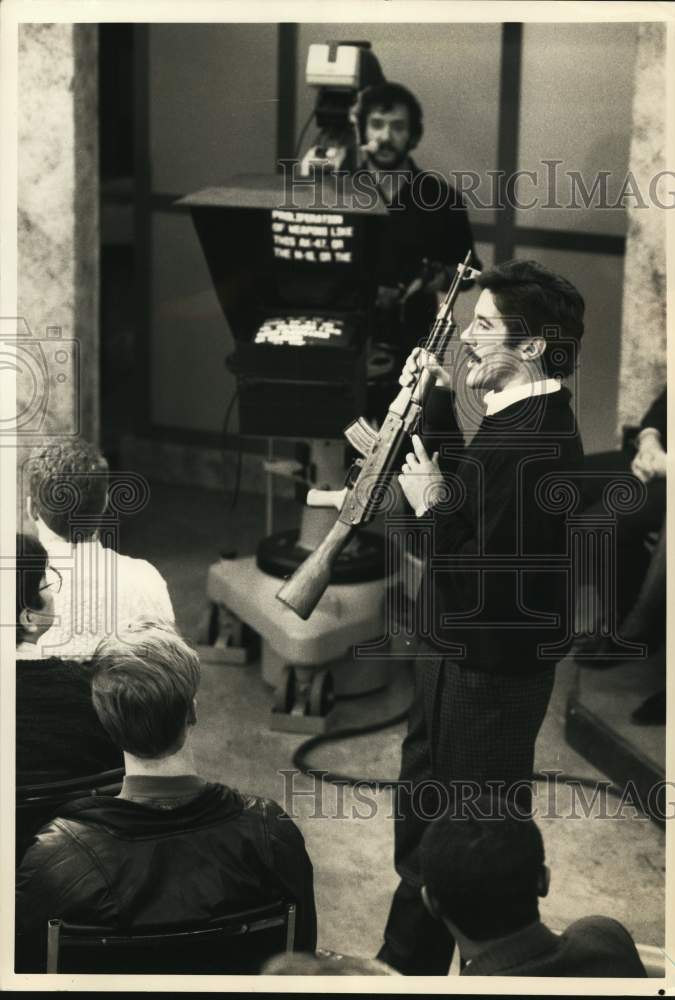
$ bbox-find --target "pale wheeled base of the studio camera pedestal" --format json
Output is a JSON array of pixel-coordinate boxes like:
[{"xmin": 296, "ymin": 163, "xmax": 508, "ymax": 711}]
[{"xmin": 206, "ymin": 556, "xmax": 389, "ymax": 733}]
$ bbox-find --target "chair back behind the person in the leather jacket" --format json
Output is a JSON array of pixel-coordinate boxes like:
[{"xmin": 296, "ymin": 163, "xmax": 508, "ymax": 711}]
[{"xmin": 46, "ymin": 900, "xmax": 295, "ymax": 975}]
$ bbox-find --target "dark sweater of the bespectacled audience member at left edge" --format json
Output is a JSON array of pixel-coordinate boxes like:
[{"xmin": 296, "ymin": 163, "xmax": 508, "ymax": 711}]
[{"xmin": 16, "ymin": 657, "xmax": 124, "ymax": 785}]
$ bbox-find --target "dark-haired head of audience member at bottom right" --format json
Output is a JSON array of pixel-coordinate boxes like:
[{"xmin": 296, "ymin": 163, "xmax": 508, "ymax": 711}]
[{"xmin": 421, "ymin": 797, "xmax": 544, "ymax": 941}]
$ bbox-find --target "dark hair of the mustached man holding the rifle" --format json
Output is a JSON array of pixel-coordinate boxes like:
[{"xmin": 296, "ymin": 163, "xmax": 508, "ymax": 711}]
[{"xmin": 477, "ymin": 260, "xmax": 584, "ymax": 378}]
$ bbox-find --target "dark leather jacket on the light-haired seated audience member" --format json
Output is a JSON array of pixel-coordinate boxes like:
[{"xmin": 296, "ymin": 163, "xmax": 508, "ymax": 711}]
[{"xmin": 16, "ymin": 784, "xmax": 316, "ymax": 964}]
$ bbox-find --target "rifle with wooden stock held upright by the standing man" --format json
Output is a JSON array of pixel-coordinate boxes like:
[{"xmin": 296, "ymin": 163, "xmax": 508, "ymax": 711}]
[{"xmin": 277, "ymin": 251, "xmax": 478, "ymax": 620}]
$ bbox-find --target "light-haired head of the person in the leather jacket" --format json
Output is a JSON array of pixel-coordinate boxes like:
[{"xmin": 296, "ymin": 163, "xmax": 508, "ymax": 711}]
[{"xmin": 92, "ymin": 618, "xmax": 200, "ymax": 758}]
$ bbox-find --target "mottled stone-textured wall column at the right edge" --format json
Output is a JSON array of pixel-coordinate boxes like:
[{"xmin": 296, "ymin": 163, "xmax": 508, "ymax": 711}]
[{"xmin": 617, "ymin": 22, "xmax": 672, "ymax": 433}]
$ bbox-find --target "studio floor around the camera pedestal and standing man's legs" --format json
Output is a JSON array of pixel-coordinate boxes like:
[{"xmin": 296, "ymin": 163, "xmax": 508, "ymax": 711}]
[{"xmin": 120, "ymin": 484, "xmax": 665, "ymax": 955}]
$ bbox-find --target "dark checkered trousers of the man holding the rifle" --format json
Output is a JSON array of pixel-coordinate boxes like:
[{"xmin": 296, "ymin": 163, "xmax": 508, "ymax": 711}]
[{"xmin": 394, "ymin": 656, "xmax": 555, "ymax": 881}]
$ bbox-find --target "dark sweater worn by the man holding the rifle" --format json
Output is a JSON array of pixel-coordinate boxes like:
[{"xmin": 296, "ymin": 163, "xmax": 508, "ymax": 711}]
[{"xmin": 417, "ymin": 388, "xmax": 583, "ymax": 673}]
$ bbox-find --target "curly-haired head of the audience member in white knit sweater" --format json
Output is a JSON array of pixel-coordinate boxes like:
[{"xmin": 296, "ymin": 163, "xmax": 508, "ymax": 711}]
[{"xmin": 29, "ymin": 440, "xmax": 108, "ymax": 542}]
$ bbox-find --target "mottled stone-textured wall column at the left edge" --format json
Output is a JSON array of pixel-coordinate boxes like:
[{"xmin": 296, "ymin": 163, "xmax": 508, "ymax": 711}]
[{"xmin": 17, "ymin": 24, "xmax": 99, "ymax": 520}]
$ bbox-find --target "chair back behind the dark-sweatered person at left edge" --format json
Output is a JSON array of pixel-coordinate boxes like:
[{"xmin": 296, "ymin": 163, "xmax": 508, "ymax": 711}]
[{"xmin": 16, "ymin": 767, "xmax": 124, "ymax": 865}]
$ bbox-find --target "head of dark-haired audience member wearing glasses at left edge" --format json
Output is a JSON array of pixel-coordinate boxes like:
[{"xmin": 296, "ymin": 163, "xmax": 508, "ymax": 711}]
[{"xmin": 16, "ymin": 534, "xmax": 60, "ymax": 646}]
